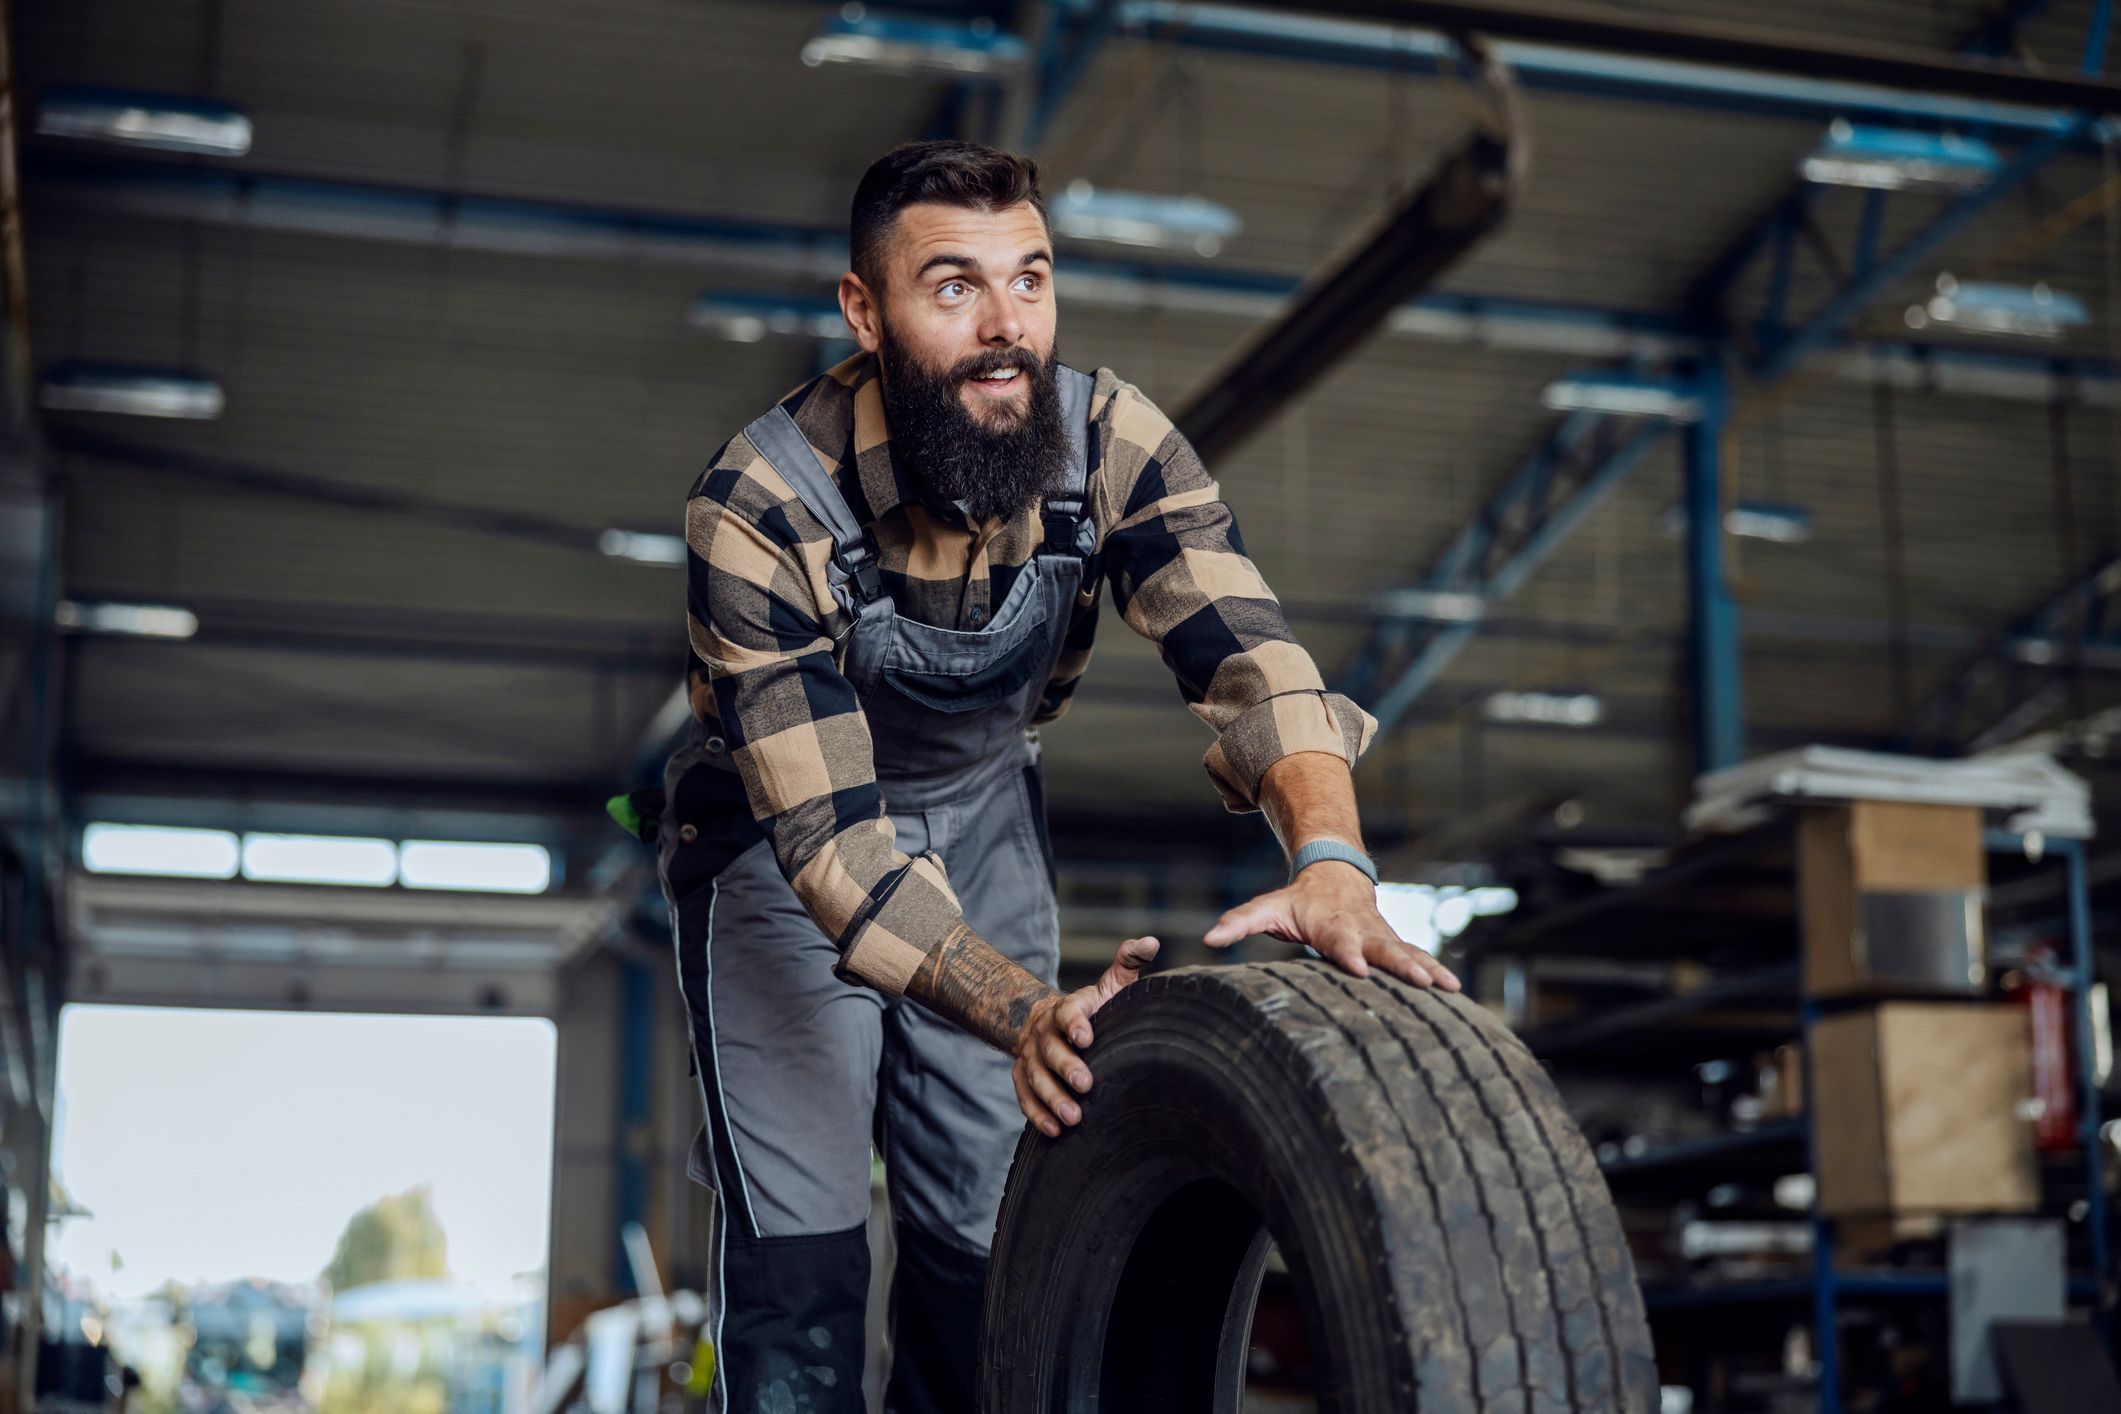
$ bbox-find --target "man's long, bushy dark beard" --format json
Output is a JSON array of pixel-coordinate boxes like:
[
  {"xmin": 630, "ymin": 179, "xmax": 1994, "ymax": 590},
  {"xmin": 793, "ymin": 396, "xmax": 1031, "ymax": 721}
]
[{"xmin": 882, "ymin": 326, "xmax": 1069, "ymax": 522}]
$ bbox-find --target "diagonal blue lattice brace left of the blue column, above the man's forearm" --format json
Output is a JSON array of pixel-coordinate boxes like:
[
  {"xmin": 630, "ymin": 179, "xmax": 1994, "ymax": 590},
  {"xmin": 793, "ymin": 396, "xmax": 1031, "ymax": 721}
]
[{"xmin": 1343, "ymin": 411, "xmax": 1669, "ymax": 731}]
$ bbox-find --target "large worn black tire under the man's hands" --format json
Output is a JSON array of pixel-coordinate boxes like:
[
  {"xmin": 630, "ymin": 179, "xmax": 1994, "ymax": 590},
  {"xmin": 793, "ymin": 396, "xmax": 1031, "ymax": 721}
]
[{"xmin": 980, "ymin": 962, "xmax": 1657, "ymax": 1414}]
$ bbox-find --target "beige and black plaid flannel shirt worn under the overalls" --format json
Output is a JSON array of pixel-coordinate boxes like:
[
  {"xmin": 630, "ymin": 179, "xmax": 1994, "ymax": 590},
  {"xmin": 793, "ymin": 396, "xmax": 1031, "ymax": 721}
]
[{"xmin": 685, "ymin": 354, "xmax": 1377, "ymax": 996}]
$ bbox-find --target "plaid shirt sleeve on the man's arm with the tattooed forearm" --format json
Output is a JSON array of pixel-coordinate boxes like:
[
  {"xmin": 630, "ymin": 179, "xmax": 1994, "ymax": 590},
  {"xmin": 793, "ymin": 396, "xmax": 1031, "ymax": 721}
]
[{"xmin": 685, "ymin": 439, "xmax": 965, "ymax": 996}]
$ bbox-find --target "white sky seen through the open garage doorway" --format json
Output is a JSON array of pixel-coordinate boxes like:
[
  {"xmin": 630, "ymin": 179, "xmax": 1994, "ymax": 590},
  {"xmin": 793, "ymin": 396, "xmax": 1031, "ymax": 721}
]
[{"xmin": 49, "ymin": 1005, "xmax": 558, "ymax": 1297}]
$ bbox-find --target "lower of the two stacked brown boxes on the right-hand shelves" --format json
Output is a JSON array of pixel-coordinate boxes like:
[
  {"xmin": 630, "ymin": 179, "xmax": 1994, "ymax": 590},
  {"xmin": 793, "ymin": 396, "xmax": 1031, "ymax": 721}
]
[{"xmin": 1811, "ymin": 1003, "xmax": 2040, "ymax": 1217}]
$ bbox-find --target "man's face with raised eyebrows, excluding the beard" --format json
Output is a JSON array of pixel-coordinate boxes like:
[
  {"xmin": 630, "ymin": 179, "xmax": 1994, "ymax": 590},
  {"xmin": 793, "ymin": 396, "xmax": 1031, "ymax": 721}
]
[{"xmin": 857, "ymin": 201, "xmax": 1054, "ymax": 432}]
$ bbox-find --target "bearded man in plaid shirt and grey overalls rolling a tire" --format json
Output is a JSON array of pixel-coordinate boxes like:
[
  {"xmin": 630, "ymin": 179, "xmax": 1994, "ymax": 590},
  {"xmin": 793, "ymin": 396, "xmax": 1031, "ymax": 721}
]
[{"xmin": 660, "ymin": 142, "xmax": 1457, "ymax": 1414}]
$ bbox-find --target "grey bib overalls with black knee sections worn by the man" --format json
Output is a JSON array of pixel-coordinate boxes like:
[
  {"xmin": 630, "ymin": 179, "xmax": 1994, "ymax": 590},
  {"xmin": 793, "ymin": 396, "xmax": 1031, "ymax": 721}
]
[{"xmin": 660, "ymin": 367, "xmax": 1097, "ymax": 1414}]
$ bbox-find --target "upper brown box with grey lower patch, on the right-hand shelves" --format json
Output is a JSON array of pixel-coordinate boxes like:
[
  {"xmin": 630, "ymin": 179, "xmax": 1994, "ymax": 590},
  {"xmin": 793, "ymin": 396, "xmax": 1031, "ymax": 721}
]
[{"xmin": 1796, "ymin": 801, "xmax": 1987, "ymax": 996}]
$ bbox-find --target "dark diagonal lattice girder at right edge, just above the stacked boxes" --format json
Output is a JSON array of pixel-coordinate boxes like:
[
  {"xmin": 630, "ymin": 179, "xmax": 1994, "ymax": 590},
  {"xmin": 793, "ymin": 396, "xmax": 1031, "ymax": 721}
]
[{"xmin": 1907, "ymin": 555, "xmax": 2121, "ymax": 750}]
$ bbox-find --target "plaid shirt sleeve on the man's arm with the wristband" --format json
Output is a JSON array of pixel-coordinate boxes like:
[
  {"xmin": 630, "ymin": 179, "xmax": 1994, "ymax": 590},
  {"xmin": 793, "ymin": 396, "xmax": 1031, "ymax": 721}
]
[{"xmin": 1097, "ymin": 375, "xmax": 1377, "ymax": 810}]
